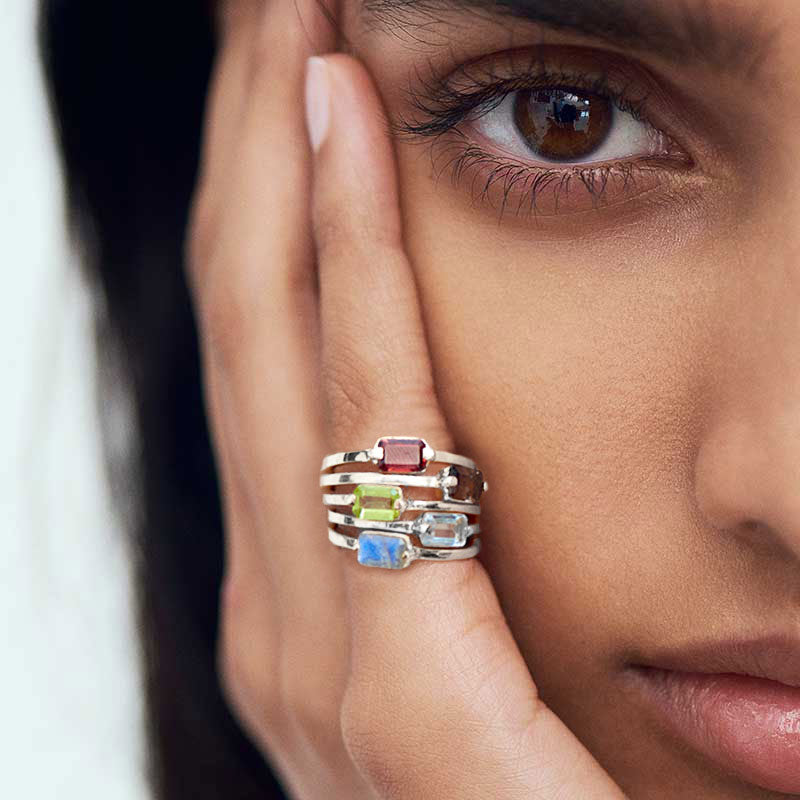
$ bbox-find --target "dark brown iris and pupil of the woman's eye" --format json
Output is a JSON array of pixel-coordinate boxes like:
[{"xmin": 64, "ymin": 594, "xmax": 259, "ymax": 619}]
[{"xmin": 514, "ymin": 89, "xmax": 614, "ymax": 161}]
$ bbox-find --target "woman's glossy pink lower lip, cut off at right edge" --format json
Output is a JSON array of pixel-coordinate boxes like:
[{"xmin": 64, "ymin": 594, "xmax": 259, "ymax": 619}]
[{"xmin": 631, "ymin": 666, "xmax": 800, "ymax": 794}]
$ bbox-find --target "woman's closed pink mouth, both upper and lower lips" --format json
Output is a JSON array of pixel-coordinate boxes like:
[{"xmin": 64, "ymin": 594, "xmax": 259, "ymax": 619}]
[{"xmin": 628, "ymin": 634, "xmax": 800, "ymax": 793}]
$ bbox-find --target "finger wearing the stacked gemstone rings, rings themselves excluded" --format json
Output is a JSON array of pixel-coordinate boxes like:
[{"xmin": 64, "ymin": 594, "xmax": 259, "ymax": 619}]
[{"xmin": 312, "ymin": 54, "xmax": 622, "ymax": 800}]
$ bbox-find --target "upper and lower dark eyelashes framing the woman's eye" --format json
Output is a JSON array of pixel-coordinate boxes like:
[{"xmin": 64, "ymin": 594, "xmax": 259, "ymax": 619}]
[{"xmin": 390, "ymin": 55, "xmax": 691, "ymax": 218}]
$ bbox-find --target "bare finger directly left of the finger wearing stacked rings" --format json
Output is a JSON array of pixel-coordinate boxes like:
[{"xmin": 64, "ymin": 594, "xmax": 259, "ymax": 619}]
[{"xmin": 188, "ymin": 0, "xmax": 354, "ymax": 740}]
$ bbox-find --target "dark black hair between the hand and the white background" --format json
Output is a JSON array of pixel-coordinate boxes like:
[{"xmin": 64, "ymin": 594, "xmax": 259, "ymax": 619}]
[{"xmin": 39, "ymin": 0, "xmax": 283, "ymax": 800}]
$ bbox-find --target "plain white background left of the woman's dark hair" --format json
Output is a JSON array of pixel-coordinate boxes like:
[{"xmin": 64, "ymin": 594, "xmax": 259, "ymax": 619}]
[{"xmin": 0, "ymin": 0, "xmax": 147, "ymax": 800}]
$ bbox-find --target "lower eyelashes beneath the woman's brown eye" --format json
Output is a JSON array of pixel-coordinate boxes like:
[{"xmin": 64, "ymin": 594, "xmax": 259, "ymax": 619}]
[{"xmin": 424, "ymin": 134, "xmax": 686, "ymax": 223}]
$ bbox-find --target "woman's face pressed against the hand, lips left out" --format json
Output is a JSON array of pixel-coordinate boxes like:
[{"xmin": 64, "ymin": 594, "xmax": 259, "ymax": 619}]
[{"xmin": 258, "ymin": 0, "xmax": 800, "ymax": 800}]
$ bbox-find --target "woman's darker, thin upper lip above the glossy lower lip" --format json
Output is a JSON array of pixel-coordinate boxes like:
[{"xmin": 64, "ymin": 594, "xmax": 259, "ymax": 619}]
[{"xmin": 635, "ymin": 634, "xmax": 800, "ymax": 687}]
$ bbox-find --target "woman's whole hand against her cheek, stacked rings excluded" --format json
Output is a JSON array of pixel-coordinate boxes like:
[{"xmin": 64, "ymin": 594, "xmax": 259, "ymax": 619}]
[{"xmin": 188, "ymin": 0, "xmax": 624, "ymax": 800}]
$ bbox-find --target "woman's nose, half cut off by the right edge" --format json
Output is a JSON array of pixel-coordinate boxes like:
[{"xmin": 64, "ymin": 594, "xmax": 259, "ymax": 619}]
[{"xmin": 695, "ymin": 231, "xmax": 800, "ymax": 561}]
